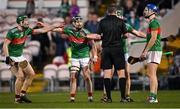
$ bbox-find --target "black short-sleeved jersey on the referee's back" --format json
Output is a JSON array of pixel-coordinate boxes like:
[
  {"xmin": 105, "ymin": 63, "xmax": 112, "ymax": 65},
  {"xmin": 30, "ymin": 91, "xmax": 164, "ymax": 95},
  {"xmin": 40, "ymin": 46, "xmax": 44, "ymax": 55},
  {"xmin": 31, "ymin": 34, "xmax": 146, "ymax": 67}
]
[{"xmin": 97, "ymin": 15, "xmax": 127, "ymax": 48}]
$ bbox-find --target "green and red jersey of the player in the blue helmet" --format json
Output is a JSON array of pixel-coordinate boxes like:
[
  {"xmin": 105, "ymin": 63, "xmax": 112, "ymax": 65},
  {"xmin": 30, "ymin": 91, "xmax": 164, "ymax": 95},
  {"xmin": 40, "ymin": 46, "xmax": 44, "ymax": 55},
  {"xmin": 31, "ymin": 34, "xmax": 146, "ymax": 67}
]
[{"xmin": 147, "ymin": 19, "xmax": 162, "ymax": 51}]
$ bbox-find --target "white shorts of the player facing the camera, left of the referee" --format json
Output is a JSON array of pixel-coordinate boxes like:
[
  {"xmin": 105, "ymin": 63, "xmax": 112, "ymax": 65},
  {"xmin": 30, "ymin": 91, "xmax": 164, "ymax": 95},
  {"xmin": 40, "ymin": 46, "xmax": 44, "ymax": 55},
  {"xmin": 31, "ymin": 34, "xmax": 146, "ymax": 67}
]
[{"xmin": 71, "ymin": 57, "xmax": 90, "ymax": 73}]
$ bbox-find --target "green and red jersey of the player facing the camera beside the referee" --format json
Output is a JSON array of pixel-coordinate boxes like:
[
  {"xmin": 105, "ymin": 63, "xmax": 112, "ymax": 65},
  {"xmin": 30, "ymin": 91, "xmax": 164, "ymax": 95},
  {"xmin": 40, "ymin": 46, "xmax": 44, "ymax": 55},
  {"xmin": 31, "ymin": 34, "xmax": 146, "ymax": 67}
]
[{"xmin": 64, "ymin": 27, "xmax": 90, "ymax": 58}]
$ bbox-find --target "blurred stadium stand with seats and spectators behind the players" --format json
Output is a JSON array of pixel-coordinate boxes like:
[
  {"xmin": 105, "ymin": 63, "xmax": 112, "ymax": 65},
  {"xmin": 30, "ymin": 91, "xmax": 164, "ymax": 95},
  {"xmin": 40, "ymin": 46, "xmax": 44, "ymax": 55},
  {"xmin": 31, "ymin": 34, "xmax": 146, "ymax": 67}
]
[{"xmin": 0, "ymin": 0, "xmax": 180, "ymax": 92}]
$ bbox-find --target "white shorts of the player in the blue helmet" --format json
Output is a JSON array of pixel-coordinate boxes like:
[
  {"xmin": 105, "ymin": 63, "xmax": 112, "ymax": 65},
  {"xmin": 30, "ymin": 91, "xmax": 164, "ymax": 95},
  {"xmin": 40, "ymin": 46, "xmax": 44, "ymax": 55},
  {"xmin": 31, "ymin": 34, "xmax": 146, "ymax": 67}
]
[{"xmin": 147, "ymin": 51, "xmax": 162, "ymax": 64}]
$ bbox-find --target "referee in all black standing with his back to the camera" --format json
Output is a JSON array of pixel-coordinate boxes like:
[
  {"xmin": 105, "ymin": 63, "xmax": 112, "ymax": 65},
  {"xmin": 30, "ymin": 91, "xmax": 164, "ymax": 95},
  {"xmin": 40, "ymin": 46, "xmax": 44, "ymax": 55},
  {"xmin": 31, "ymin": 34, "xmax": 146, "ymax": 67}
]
[{"xmin": 97, "ymin": 5, "xmax": 127, "ymax": 103}]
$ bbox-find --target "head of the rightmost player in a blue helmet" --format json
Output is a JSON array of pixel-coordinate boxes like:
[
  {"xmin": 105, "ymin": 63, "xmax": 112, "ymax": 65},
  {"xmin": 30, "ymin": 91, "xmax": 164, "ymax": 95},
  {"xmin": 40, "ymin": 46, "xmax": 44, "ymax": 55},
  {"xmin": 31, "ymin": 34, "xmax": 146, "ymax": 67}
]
[{"xmin": 143, "ymin": 4, "xmax": 159, "ymax": 18}]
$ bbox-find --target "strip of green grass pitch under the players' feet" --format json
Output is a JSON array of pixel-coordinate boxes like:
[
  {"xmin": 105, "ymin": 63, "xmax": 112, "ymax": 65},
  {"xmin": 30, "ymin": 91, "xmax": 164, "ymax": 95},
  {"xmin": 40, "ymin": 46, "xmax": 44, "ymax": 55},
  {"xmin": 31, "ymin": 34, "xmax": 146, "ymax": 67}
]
[{"xmin": 0, "ymin": 91, "xmax": 180, "ymax": 108}]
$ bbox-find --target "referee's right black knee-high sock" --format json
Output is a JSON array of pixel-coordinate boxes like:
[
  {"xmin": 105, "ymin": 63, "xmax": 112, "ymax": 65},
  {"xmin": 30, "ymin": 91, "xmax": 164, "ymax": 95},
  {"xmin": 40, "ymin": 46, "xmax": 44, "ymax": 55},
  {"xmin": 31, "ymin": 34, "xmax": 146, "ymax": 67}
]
[{"xmin": 119, "ymin": 78, "xmax": 126, "ymax": 99}]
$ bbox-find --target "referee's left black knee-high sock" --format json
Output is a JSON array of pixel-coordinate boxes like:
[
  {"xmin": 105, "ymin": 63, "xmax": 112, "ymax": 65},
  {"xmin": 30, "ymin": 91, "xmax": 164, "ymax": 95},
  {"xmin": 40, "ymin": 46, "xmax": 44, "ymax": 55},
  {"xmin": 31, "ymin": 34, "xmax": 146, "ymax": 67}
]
[{"xmin": 104, "ymin": 78, "xmax": 111, "ymax": 99}]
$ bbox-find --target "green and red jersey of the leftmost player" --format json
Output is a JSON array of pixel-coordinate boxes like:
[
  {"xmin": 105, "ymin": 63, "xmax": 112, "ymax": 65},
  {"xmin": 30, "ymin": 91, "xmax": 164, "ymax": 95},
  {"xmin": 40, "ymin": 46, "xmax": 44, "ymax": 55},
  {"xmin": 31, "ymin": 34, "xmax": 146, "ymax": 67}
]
[{"xmin": 6, "ymin": 27, "xmax": 33, "ymax": 57}]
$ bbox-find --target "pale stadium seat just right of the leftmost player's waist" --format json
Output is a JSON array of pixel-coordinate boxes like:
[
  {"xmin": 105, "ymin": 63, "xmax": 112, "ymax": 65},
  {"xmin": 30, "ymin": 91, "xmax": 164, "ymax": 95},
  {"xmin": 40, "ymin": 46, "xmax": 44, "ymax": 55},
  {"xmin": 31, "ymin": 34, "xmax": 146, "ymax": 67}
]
[{"xmin": 27, "ymin": 41, "xmax": 40, "ymax": 56}]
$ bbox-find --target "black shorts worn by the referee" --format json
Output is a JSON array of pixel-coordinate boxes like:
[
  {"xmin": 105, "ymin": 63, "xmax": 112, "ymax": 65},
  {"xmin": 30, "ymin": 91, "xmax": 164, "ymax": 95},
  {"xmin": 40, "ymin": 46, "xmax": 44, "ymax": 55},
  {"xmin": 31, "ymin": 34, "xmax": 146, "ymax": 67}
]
[{"xmin": 101, "ymin": 47, "xmax": 125, "ymax": 70}]
